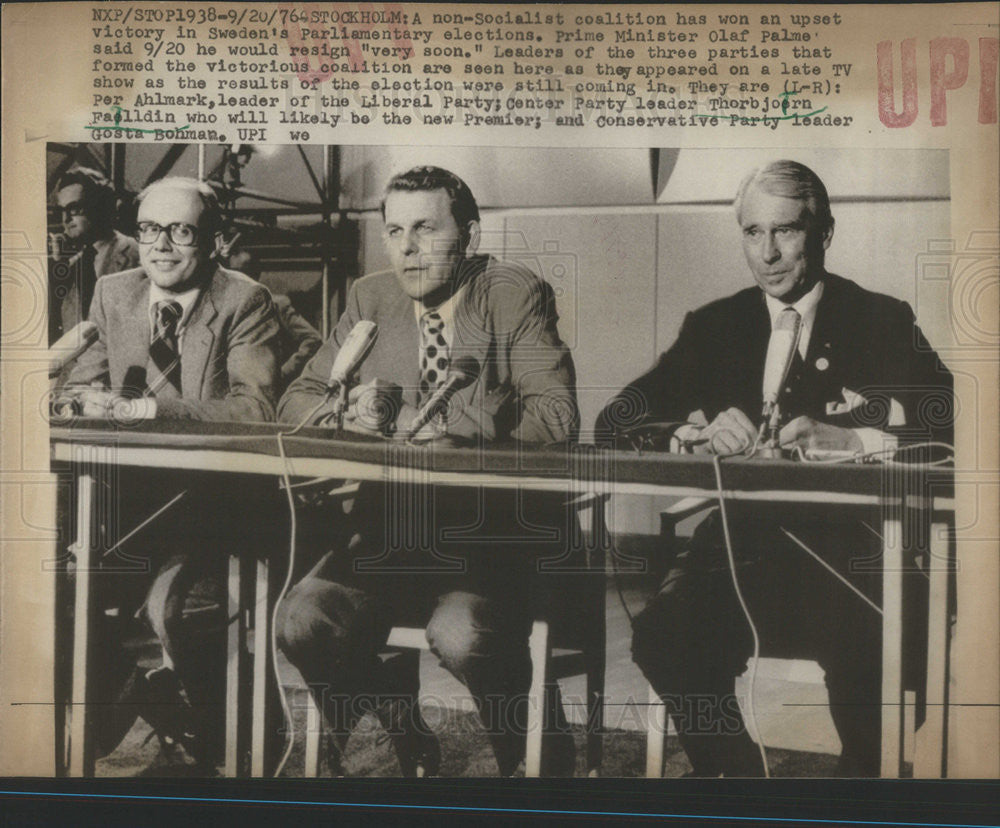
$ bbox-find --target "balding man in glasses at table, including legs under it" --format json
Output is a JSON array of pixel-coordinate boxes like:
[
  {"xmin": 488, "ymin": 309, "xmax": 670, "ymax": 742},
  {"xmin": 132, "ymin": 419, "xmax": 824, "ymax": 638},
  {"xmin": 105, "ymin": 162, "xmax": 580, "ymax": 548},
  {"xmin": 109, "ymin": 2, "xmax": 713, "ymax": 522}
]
[{"xmin": 64, "ymin": 178, "xmax": 280, "ymax": 760}]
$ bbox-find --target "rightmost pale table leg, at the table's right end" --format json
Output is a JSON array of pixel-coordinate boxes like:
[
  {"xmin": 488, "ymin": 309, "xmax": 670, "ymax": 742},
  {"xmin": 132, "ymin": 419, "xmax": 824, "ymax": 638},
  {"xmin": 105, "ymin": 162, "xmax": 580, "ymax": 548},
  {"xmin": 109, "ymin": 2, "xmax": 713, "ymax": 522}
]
[{"xmin": 913, "ymin": 523, "xmax": 951, "ymax": 779}]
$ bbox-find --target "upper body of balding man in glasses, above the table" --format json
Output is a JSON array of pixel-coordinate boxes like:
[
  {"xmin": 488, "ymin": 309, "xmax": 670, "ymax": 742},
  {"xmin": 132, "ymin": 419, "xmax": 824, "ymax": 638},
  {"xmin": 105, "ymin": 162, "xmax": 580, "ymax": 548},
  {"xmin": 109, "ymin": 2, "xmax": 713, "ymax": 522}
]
[{"xmin": 69, "ymin": 178, "xmax": 280, "ymax": 422}]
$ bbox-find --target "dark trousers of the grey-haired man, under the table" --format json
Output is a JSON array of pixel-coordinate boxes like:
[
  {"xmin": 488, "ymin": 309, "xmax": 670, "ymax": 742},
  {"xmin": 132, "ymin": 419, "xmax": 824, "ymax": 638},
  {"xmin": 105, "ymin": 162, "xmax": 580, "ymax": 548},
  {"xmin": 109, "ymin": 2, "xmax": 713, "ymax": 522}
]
[{"xmin": 633, "ymin": 507, "xmax": 881, "ymax": 775}]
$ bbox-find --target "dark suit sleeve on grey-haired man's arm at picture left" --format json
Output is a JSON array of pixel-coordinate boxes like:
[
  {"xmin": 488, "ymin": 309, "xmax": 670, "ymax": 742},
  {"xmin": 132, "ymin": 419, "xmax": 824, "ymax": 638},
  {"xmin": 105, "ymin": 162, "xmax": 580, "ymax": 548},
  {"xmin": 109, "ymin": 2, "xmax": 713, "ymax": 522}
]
[{"xmin": 594, "ymin": 313, "xmax": 709, "ymax": 443}]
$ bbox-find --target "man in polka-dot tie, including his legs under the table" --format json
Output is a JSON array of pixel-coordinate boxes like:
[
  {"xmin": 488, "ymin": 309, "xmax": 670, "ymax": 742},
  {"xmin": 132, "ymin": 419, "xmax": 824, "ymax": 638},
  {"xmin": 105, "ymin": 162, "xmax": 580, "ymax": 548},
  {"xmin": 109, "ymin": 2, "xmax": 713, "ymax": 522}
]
[{"xmin": 277, "ymin": 167, "xmax": 577, "ymax": 775}]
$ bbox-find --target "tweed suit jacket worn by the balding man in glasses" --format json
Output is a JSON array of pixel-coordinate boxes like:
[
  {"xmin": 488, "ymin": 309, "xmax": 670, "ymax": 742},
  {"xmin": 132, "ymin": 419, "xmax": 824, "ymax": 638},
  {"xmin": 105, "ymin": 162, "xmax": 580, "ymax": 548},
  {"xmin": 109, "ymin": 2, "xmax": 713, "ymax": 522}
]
[{"xmin": 69, "ymin": 267, "xmax": 280, "ymax": 421}]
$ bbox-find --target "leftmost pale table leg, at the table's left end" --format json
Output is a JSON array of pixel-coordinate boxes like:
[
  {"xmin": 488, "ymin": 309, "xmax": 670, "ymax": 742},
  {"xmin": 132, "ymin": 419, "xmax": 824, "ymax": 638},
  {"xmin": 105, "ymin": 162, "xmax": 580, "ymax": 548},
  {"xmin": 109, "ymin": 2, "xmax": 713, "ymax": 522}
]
[{"xmin": 69, "ymin": 472, "xmax": 97, "ymax": 776}]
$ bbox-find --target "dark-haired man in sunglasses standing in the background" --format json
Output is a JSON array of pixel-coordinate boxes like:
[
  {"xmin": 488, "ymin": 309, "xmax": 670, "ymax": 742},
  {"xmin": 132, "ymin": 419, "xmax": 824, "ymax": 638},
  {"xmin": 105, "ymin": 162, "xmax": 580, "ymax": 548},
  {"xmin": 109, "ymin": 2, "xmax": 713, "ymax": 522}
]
[{"xmin": 49, "ymin": 167, "xmax": 139, "ymax": 343}]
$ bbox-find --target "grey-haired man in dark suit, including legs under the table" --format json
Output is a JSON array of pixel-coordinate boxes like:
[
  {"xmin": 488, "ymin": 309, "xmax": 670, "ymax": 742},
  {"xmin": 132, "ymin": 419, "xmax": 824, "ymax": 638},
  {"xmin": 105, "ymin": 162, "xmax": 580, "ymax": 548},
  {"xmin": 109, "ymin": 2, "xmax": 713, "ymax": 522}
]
[{"xmin": 597, "ymin": 161, "xmax": 952, "ymax": 776}]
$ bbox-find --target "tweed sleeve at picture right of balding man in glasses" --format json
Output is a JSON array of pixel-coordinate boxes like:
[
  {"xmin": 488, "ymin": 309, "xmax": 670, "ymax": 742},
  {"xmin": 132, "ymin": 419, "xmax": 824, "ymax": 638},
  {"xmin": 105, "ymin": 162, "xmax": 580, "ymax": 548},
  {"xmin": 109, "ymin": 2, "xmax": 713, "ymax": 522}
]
[{"xmin": 157, "ymin": 286, "xmax": 281, "ymax": 422}]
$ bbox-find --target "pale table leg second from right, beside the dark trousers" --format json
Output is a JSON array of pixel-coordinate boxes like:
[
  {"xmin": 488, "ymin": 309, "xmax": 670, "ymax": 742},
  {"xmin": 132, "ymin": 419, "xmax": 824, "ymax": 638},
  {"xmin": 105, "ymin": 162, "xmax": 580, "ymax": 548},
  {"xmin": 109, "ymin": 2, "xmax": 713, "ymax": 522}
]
[{"xmin": 882, "ymin": 518, "xmax": 904, "ymax": 779}]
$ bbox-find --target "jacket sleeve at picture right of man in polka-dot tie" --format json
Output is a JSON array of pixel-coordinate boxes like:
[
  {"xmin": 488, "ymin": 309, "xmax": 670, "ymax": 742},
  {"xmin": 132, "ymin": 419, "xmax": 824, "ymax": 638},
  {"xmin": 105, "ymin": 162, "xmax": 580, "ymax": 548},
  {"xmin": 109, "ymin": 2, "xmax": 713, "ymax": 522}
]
[{"xmin": 497, "ymin": 276, "xmax": 579, "ymax": 443}]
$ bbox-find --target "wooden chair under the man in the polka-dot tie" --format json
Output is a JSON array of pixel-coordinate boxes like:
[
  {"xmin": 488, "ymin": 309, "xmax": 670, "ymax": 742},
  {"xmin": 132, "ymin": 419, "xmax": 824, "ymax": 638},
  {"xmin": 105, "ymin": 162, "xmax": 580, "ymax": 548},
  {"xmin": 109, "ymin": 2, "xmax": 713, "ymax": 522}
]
[{"xmin": 296, "ymin": 495, "xmax": 610, "ymax": 778}]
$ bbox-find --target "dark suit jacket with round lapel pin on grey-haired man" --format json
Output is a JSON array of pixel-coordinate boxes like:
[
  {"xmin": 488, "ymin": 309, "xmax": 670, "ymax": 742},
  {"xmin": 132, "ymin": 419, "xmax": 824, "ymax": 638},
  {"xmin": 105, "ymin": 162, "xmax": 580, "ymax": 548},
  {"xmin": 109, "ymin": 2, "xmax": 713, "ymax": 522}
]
[{"xmin": 597, "ymin": 273, "xmax": 954, "ymax": 444}]
